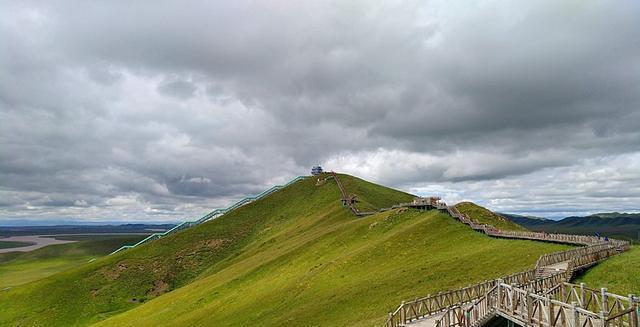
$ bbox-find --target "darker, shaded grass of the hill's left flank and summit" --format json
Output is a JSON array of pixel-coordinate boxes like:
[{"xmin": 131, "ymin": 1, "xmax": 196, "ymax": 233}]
[{"xmin": 0, "ymin": 176, "xmax": 411, "ymax": 326}]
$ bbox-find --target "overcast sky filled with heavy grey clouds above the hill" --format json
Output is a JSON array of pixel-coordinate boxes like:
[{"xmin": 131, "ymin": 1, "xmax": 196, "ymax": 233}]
[{"xmin": 0, "ymin": 0, "xmax": 640, "ymax": 224}]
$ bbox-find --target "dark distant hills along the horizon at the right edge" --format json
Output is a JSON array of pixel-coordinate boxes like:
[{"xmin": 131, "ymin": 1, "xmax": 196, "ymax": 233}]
[{"xmin": 500, "ymin": 212, "xmax": 640, "ymax": 241}]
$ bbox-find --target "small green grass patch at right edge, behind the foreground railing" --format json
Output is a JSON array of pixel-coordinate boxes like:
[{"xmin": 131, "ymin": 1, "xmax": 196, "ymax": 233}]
[{"xmin": 576, "ymin": 246, "xmax": 640, "ymax": 296}]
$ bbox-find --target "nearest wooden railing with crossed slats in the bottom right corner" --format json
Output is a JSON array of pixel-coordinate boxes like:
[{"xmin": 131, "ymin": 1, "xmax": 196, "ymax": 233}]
[{"xmin": 435, "ymin": 283, "xmax": 640, "ymax": 327}]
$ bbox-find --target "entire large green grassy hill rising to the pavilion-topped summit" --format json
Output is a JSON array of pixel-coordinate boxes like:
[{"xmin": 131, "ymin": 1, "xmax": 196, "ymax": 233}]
[{"xmin": 0, "ymin": 175, "xmax": 566, "ymax": 326}]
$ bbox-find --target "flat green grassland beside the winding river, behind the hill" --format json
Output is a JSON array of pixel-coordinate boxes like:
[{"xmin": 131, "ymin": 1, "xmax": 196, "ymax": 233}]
[{"xmin": 0, "ymin": 235, "xmax": 141, "ymax": 289}]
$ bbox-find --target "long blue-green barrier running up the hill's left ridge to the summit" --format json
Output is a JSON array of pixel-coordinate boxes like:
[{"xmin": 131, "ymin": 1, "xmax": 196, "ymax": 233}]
[{"xmin": 109, "ymin": 176, "xmax": 306, "ymax": 255}]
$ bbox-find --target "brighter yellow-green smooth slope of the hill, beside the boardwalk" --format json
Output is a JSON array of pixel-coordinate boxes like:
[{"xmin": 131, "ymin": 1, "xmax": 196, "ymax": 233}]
[{"xmin": 92, "ymin": 208, "xmax": 566, "ymax": 326}]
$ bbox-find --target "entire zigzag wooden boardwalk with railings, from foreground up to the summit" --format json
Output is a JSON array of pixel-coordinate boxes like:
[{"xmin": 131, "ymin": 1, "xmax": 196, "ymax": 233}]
[{"xmin": 324, "ymin": 176, "xmax": 640, "ymax": 327}]
